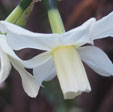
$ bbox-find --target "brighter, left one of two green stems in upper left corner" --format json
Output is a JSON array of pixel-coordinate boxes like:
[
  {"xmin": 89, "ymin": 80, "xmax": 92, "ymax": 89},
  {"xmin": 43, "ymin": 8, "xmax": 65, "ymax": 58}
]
[{"xmin": 5, "ymin": 0, "xmax": 32, "ymax": 23}]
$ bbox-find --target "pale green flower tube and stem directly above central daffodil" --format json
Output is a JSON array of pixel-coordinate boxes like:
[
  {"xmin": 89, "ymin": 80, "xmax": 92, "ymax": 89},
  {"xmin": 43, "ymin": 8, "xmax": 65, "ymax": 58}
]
[{"xmin": 43, "ymin": 0, "xmax": 65, "ymax": 33}]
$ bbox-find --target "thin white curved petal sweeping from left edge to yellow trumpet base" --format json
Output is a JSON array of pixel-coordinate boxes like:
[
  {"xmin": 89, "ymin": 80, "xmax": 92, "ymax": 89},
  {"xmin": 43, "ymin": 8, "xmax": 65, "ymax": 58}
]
[{"xmin": 0, "ymin": 37, "xmax": 50, "ymax": 68}]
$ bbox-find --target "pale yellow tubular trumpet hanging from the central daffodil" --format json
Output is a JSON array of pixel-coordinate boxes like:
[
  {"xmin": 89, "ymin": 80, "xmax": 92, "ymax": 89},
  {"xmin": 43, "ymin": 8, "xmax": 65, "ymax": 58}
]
[{"xmin": 53, "ymin": 46, "xmax": 91, "ymax": 99}]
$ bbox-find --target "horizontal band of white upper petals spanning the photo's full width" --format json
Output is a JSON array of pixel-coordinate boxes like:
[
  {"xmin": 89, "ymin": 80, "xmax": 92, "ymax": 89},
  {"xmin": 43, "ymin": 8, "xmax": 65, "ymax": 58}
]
[{"xmin": 0, "ymin": 12, "xmax": 113, "ymax": 51}]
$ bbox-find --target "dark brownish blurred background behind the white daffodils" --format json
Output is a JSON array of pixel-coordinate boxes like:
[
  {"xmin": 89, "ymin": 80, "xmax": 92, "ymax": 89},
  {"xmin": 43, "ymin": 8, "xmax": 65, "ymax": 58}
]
[{"xmin": 0, "ymin": 0, "xmax": 113, "ymax": 112}]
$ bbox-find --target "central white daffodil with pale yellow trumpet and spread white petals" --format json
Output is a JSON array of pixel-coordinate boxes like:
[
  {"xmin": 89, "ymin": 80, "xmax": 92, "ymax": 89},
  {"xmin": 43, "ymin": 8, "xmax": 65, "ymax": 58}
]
[{"xmin": 0, "ymin": 12, "xmax": 113, "ymax": 99}]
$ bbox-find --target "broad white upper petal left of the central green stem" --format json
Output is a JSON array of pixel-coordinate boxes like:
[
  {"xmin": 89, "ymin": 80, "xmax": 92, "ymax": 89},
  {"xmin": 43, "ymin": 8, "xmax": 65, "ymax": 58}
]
[{"xmin": 0, "ymin": 21, "xmax": 60, "ymax": 50}]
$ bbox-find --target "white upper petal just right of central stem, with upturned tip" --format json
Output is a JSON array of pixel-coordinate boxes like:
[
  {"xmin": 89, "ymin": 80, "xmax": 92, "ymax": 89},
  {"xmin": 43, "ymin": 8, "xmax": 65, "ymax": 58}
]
[{"xmin": 61, "ymin": 18, "xmax": 96, "ymax": 46}]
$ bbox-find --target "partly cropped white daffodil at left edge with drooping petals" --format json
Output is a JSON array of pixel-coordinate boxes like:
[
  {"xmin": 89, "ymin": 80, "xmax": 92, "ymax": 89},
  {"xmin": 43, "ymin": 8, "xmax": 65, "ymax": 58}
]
[{"xmin": 0, "ymin": 31, "xmax": 40, "ymax": 97}]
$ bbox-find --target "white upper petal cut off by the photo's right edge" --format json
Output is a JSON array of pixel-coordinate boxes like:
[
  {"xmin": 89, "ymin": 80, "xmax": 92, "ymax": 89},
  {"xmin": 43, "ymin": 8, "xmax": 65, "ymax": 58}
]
[{"xmin": 89, "ymin": 12, "xmax": 113, "ymax": 40}]
